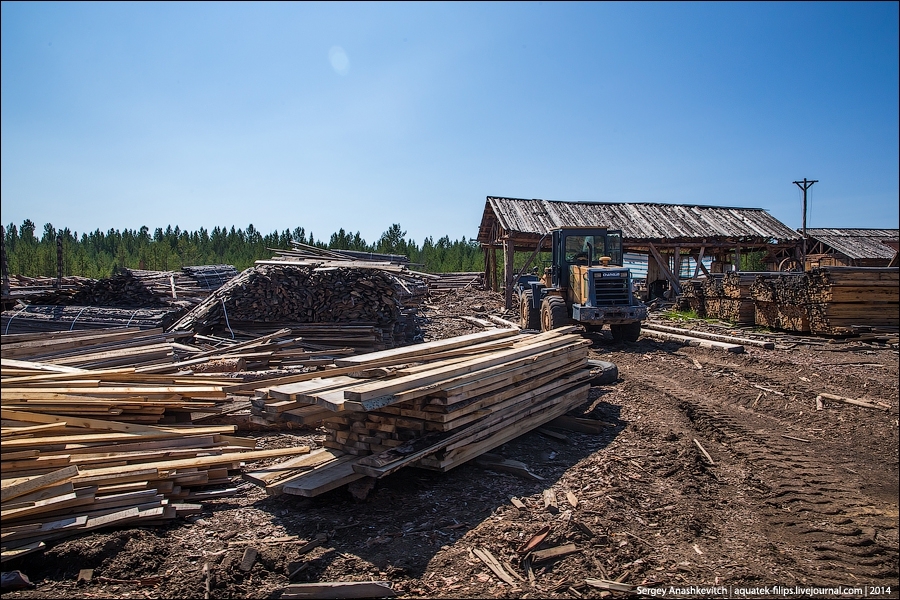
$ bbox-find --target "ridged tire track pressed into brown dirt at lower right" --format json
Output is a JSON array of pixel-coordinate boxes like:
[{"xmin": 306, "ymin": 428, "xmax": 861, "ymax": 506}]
[{"xmin": 642, "ymin": 374, "xmax": 898, "ymax": 584}]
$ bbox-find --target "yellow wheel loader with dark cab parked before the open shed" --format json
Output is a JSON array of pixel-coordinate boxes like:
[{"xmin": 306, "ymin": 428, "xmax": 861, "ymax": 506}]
[{"xmin": 515, "ymin": 227, "xmax": 647, "ymax": 342}]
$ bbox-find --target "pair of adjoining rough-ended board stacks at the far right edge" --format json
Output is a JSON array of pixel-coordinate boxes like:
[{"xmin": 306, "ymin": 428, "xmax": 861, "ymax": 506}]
[{"xmin": 751, "ymin": 267, "xmax": 900, "ymax": 335}]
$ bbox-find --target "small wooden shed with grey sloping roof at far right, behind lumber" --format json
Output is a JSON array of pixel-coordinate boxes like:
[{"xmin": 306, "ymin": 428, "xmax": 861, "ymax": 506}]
[{"xmin": 806, "ymin": 228, "xmax": 900, "ymax": 270}]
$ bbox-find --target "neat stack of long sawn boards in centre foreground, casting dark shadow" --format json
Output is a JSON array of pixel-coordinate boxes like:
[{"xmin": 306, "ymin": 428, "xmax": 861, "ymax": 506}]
[{"xmin": 253, "ymin": 327, "xmax": 591, "ymax": 496}]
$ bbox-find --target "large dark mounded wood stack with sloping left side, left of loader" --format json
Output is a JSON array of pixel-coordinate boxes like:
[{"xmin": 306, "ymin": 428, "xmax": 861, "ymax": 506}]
[{"xmin": 173, "ymin": 262, "xmax": 424, "ymax": 347}]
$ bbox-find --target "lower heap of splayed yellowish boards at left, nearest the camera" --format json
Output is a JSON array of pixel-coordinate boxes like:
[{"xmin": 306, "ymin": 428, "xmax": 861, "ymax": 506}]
[{"xmin": 0, "ymin": 414, "xmax": 310, "ymax": 561}]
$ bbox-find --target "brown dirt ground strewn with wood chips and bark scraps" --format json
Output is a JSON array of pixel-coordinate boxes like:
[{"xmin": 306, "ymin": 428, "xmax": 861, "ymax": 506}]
[{"xmin": 3, "ymin": 293, "xmax": 900, "ymax": 599}]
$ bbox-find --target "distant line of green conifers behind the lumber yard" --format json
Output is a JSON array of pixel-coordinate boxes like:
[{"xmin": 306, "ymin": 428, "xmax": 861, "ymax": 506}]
[{"xmin": 3, "ymin": 219, "xmax": 484, "ymax": 279}]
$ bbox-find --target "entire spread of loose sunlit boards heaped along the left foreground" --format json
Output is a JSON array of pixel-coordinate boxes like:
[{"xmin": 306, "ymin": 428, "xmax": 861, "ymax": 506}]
[{"xmin": 0, "ymin": 346, "xmax": 309, "ymax": 561}]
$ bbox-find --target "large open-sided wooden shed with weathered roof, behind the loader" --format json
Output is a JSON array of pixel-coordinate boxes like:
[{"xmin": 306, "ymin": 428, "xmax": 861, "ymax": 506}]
[{"xmin": 478, "ymin": 196, "xmax": 802, "ymax": 307}]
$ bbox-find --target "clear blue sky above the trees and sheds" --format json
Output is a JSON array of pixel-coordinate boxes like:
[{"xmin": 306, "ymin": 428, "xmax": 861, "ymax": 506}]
[{"xmin": 0, "ymin": 2, "xmax": 900, "ymax": 243}]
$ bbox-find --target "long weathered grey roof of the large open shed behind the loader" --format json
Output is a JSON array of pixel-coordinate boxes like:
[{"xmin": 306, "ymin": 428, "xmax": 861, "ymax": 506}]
[{"xmin": 478, "ymin": 196, "xmax": 800, "ymax": 243}]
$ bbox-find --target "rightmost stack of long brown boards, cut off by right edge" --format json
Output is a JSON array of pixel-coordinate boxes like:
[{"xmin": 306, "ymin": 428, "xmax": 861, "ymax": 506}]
[{"xmin": 807, "ymin": 267, "xmax": 900, "ymax": 335}]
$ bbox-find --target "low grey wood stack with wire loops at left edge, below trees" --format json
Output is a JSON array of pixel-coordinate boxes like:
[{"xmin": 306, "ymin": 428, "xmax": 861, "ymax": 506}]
[{"xmin": 0, "ymin": 305, "xmax": 183, "ymax": 334}]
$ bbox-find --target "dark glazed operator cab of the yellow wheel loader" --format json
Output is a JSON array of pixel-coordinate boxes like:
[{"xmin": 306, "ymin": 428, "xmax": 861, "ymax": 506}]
[{"xmin": 550, "ymin": 227, "xmax": 622, "ymax": 290}]
